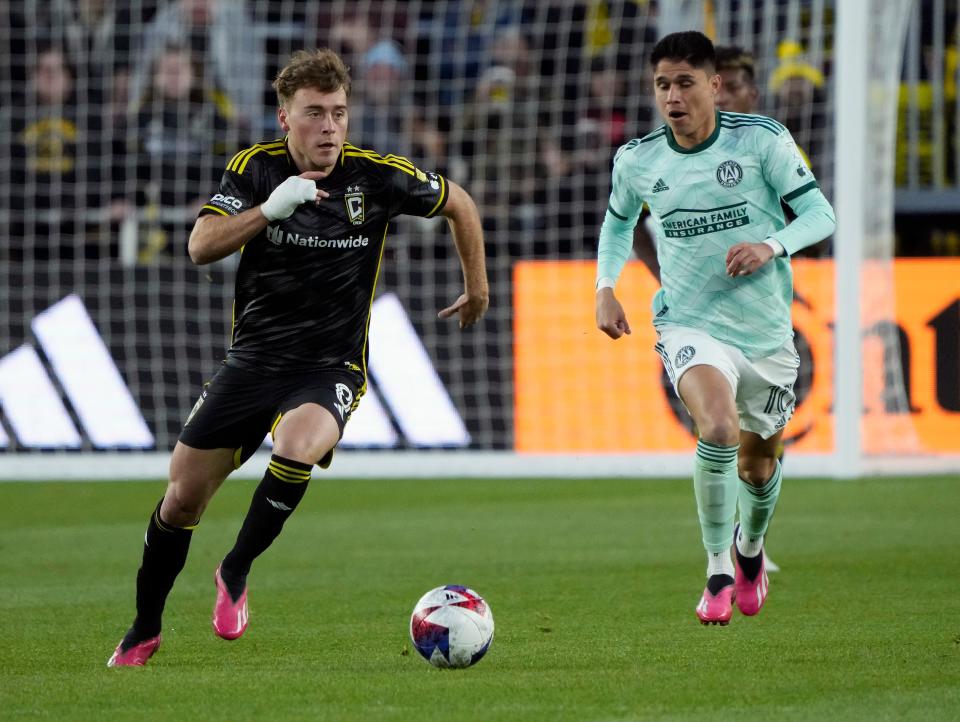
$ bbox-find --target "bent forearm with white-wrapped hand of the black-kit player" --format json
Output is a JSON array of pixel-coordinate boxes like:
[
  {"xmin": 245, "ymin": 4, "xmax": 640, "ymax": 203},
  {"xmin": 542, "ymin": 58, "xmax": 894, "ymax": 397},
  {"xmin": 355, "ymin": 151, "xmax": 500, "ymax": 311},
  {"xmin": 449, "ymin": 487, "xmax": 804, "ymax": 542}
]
[{"xmin": 187, "ymin": 171, "xmax": 330, "ymax": 266}]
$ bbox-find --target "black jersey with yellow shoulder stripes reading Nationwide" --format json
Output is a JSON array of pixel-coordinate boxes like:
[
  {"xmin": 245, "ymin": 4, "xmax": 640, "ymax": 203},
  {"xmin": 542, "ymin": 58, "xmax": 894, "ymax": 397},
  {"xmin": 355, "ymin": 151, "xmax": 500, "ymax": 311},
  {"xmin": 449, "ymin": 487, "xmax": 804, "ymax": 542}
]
[{"xmin": 200, "ymin": 139, "xmax": 448, "ymax": 376}]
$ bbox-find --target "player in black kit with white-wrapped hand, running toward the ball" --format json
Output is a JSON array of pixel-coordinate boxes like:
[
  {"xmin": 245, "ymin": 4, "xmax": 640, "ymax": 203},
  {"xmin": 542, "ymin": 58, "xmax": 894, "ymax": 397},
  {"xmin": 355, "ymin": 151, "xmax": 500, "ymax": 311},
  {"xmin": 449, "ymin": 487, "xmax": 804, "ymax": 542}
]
[{"xmin": 107, "ymin": 50, "xmax": 489, "ymax": 667}]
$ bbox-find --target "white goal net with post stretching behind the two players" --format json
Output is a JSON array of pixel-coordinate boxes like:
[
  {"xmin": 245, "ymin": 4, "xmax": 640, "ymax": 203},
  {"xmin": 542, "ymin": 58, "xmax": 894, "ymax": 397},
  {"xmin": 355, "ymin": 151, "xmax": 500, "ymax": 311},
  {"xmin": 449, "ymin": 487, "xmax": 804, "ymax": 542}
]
[{"xmin": 0, "ymin": 0, "xmax": 960, "ymax": 478}]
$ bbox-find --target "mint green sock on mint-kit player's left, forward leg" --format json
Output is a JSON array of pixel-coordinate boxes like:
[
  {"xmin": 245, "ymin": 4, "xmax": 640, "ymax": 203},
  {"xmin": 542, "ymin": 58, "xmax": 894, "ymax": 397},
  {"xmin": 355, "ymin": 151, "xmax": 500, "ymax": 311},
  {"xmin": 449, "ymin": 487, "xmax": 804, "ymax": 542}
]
[{"xmin": 693, "ymin": 439, "xmax": 740, "ymax": 554}]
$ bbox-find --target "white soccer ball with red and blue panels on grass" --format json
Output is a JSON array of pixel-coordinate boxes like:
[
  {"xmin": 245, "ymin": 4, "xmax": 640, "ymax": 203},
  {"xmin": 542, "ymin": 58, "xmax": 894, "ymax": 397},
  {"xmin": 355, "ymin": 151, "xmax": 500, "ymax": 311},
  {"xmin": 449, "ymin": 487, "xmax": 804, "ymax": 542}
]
[{"xmin": 410, "ymin": 584, "xmax": 493, "ymax": 667}]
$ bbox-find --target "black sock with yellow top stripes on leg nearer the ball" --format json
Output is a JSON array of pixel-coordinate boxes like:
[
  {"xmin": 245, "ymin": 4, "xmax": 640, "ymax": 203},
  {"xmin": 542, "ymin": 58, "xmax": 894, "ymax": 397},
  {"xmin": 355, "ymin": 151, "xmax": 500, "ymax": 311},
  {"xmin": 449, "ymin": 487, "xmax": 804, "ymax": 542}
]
[{"xmin": 220, "ymin": 454, "xmax": 313, "ymax": 601}]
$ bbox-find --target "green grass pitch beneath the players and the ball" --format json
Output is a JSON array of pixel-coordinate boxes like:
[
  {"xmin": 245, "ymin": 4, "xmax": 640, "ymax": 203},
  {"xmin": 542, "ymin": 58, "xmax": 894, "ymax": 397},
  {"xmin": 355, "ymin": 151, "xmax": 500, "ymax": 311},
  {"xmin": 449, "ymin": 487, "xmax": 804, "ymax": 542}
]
[{"xmin": 0, "ymin": 473, "xmax": 960, "ymax": 722}]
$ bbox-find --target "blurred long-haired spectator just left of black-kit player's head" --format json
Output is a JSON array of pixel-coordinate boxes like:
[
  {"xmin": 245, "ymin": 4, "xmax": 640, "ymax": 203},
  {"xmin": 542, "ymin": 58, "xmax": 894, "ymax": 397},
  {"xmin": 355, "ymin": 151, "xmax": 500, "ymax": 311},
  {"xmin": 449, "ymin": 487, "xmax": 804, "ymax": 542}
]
[{"xmin": 130, "ymin": 45, "xmax": 241, "ymax": 261}]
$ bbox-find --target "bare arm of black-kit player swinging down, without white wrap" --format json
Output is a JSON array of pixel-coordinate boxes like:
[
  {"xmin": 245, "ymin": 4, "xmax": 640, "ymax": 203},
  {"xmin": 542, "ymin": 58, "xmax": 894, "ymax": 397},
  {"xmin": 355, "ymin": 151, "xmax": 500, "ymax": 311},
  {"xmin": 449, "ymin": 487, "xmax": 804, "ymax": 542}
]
[{"xmin": 437, "ymin": 181, "xmax": 490, "ymax": 328}]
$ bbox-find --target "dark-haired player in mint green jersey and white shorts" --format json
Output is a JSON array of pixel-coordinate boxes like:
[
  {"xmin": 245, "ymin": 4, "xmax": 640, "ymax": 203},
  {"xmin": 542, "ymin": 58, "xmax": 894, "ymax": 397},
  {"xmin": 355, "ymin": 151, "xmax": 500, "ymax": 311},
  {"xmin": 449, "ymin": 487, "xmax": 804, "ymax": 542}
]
[{"xmin": 596, "ymin": 31, "xmax": 836, "ymax": 624}]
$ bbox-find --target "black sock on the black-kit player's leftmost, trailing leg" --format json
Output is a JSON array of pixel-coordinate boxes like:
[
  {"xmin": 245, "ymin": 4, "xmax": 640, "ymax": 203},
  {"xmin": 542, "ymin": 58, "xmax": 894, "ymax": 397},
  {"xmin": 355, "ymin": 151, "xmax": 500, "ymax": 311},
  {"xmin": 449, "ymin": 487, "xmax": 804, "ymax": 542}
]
[{"xmin": 123, "ymin": 500, "xmax": 193, "ymax": 649}]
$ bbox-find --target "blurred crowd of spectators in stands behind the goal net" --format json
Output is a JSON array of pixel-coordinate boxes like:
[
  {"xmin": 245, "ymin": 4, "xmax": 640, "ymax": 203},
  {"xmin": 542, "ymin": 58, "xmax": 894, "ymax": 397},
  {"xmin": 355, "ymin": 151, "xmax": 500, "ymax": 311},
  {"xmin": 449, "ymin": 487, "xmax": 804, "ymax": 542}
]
[{"xmin": 0, "ymin": 0, "xmax": 957, "ymax": 263}]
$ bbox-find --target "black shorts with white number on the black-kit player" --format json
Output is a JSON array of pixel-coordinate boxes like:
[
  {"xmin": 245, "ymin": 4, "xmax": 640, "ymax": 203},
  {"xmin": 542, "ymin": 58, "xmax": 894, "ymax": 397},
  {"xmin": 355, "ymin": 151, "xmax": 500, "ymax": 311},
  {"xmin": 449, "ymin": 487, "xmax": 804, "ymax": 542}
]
[{"xmin": 180, "ymin": 365, "xmax": 363, "ymax": 467}]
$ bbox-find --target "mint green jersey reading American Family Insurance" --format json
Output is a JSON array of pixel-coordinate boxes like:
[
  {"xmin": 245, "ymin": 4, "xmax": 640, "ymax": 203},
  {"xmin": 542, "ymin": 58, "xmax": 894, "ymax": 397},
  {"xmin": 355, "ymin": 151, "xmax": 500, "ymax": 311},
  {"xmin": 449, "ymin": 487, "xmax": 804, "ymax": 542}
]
[{"xmin": 609, "ymin": 112, "xmax": 819, "ymax": 358}]
